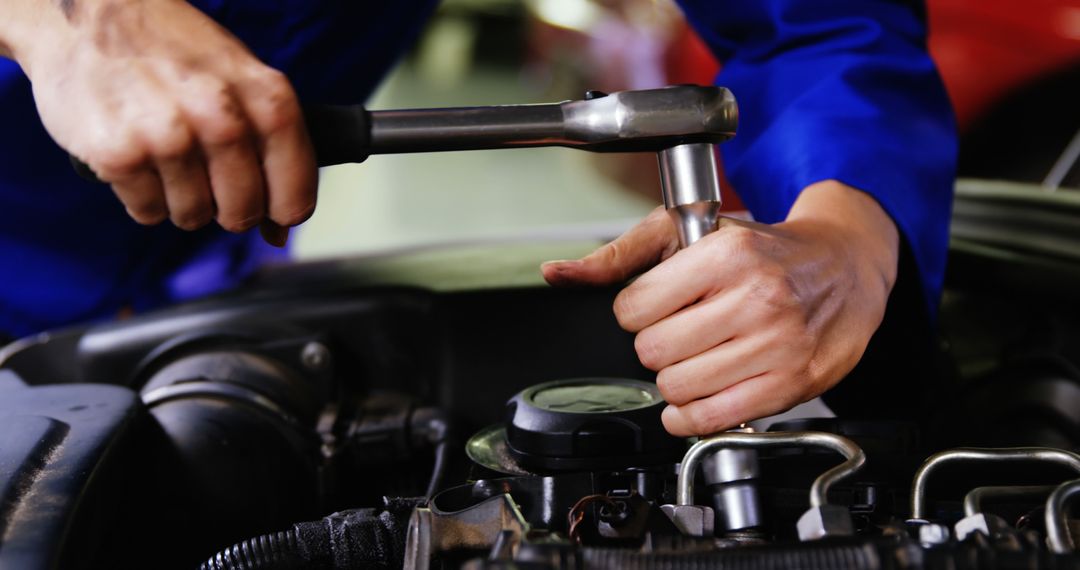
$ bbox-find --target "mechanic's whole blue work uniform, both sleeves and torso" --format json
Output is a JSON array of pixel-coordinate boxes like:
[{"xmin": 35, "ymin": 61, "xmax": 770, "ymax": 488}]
[{"xmin": 0, "ymin": 0, "xmax": 956, "ymax": 336}]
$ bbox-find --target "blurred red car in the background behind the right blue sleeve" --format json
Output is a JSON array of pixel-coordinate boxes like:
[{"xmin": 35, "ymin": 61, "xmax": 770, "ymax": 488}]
[{"xmin": 531, "ymin": 0, "xmax": 1080, "ymax": 191}]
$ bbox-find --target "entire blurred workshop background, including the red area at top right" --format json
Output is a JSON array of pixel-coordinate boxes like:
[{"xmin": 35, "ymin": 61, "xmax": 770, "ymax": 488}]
[{"xmin": 293, "ymin": 0, "xmax": 1080, "ymax": 261}]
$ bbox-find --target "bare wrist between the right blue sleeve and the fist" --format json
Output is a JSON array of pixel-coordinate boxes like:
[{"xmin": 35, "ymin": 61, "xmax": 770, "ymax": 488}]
[{"xmin": 785, "ymin": 180, "xmax": 900, "ymax": 296}]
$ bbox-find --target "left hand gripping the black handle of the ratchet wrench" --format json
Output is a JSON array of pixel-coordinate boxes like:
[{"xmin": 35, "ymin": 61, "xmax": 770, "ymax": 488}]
[{"xmin": 0, "ymin": 0, "xmax": 318, "ymax": 245}]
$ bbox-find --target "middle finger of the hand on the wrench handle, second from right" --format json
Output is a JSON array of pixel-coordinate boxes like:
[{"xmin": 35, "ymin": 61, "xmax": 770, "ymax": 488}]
[{"xmin": 186, "ymin": 81, "xmax": 266, "ymax": 232}]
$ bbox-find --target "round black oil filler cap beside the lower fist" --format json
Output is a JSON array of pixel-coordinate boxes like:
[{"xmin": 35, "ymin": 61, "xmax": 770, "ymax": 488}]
[{"xmin": 505, "ymin": 378, "xmax": 686, "ymax": 471}]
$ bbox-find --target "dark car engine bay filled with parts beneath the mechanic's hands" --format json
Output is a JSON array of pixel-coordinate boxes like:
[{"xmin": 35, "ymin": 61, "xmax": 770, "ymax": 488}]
[{"xmin": 0, "ymin": 183, "xmax": 1080, "ymax": 570}]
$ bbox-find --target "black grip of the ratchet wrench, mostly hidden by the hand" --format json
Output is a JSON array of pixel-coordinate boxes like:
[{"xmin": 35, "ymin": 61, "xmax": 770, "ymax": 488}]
[{"xmin": 68, "ymin": 105, "xmax": 372, "ymax": 182}]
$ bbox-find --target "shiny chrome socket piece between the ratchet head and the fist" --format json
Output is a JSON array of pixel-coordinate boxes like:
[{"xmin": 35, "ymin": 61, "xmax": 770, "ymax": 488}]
[{"xmin": 657, "ymin": 144, "xmax": 720, "ymax": 247}]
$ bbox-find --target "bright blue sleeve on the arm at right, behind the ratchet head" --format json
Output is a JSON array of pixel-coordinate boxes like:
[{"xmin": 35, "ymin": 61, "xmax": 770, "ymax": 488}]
[{"xmin": 680, "ymin": 0, "xmax": 957, "ymax": 314}]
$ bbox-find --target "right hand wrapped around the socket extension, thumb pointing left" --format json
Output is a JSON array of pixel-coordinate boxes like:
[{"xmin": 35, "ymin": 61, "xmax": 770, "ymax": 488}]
[{"xmin": 542, "ymin": 180, "xmax": 899, "ymax": 436}]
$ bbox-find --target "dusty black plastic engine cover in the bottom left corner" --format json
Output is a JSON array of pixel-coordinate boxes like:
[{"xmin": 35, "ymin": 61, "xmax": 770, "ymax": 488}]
[{"xmin": 0, "ymin": 370, "xmax": 145, "ymax": 568}]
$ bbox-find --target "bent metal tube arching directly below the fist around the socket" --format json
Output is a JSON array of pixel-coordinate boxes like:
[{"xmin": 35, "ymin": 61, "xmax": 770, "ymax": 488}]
[{"xmin": 675, "ymin": 432, "xmax": 866, "ymax": 507}]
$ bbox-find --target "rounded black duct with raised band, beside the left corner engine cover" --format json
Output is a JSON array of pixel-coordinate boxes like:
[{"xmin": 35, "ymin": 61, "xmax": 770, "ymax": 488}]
[{"xmin": 139, "ymin": 334, "xmax": 330, "ymax": 552}]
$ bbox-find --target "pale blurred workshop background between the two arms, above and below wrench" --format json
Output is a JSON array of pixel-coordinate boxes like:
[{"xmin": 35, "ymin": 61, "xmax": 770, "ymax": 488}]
[{"xmin": 294, "ymin": 0, "xmax": 715, "ymax": 261}]
